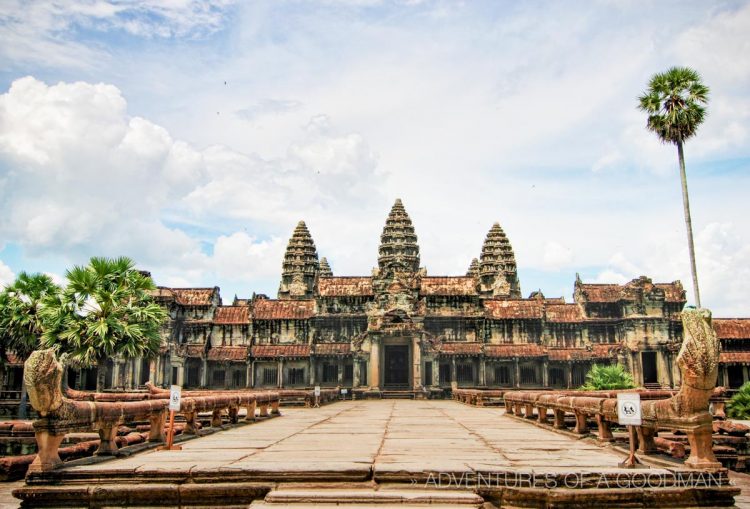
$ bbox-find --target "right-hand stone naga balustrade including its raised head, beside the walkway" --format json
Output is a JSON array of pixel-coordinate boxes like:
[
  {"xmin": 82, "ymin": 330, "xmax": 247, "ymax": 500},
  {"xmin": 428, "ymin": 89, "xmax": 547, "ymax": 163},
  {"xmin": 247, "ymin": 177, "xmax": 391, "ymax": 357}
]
[{"xmin": 504, "ymin": 309, "xmax": 721, "ymax": 469}]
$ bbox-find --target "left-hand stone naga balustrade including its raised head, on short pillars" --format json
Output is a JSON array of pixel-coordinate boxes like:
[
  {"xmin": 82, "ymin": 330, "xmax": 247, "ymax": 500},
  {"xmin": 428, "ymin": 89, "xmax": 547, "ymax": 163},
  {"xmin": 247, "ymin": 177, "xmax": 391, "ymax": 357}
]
[{"xmin": 24, "ymin": 350, "xmax": 279, "ymax": 471}]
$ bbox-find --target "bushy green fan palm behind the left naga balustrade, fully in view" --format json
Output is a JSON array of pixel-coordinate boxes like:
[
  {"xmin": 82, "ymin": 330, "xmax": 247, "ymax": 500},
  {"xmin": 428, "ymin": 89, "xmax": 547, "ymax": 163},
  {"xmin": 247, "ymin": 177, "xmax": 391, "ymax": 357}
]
[{"xmin": 42, "ymin": 257, "xmax": 167, "ymax": 391}]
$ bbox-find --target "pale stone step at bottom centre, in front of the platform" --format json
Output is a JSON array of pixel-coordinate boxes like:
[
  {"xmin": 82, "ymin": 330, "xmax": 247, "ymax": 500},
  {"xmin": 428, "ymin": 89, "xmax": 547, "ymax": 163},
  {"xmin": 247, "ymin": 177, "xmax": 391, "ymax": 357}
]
[{"xmin": 260, "ymin": 487, "xmax": 484, "ymax": 509}]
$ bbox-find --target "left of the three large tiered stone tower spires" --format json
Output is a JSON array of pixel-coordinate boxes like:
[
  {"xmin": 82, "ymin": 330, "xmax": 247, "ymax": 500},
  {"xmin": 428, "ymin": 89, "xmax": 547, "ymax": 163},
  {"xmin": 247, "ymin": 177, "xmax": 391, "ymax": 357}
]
[{"xmin": 279, "ymin": 221, "xmax": 319, "ymax": 299}]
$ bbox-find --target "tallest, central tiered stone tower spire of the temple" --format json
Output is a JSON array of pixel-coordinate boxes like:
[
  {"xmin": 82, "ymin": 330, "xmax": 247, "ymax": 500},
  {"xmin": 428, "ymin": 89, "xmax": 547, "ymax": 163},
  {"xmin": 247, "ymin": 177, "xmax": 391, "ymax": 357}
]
[{"xmin": 378, "ymin": 199, "xmax": 419, "ymax": 272}]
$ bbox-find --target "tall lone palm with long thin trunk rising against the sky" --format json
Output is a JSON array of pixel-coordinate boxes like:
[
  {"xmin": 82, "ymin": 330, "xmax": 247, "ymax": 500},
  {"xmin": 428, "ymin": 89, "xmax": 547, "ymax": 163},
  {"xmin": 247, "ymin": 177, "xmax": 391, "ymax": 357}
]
[{"xmin": 638, "ymin": 67, "xmax": 709, "ymax": 307}]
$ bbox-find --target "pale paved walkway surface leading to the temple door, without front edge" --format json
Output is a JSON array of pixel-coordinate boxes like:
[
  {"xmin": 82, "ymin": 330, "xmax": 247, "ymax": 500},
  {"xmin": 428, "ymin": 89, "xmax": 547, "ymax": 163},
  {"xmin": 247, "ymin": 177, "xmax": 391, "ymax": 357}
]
[{"xmin": 66, "ymin": 400, "xmax": 659, "ymax": 480}]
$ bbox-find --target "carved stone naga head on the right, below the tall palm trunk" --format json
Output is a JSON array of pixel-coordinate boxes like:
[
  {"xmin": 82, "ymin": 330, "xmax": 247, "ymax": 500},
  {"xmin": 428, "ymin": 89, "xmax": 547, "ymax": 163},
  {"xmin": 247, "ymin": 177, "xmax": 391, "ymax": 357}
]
[{"xmin": 677, "ymin": 309, "xmax": 719, "ymax": 390}]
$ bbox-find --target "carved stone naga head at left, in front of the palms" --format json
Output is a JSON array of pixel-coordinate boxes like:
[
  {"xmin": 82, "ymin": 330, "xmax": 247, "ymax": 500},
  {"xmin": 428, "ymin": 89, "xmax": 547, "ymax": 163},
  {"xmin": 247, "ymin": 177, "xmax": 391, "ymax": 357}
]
[{"xmin": 23, "ymin": 349, "xmax": 63, "ymax": 417}]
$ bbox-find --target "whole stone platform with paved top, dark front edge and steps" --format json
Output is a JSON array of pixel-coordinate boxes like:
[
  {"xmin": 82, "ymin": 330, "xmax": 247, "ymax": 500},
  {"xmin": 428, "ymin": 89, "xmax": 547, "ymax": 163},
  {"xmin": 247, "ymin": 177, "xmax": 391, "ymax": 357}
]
[{"xmin": 15, "ymin": 400, "xmax": 739, "ymax": 507}]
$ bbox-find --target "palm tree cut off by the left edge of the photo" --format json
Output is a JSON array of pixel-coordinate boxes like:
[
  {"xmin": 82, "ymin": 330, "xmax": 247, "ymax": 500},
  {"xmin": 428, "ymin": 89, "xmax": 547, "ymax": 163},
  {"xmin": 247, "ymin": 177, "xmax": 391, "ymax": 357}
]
[{"xmin": 0, "ymin": 272, "xmax": 60, "ymax": 419}]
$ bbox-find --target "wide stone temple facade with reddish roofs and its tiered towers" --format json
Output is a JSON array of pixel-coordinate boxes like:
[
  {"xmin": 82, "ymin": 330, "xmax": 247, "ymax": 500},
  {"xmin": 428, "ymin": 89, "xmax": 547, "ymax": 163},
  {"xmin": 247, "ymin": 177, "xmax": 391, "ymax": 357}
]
[{"xmin": 58, "ymin": 200, "xmax": 750, "ymax": 395}]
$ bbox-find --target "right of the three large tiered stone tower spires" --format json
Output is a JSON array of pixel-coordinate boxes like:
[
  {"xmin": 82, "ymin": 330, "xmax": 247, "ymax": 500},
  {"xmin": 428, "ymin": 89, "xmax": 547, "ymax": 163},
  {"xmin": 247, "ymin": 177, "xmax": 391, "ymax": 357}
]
[{"xmin": 479, "ymin": 223, "xmax": 521, "ymax": 299}]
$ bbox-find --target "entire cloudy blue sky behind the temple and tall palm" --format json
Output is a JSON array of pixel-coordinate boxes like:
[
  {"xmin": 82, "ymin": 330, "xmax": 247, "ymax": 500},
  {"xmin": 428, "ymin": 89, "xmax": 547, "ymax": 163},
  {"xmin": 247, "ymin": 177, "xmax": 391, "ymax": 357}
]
[{"xmin": 0, "ymin": 0, "xmax": 750, "ymax": 316}]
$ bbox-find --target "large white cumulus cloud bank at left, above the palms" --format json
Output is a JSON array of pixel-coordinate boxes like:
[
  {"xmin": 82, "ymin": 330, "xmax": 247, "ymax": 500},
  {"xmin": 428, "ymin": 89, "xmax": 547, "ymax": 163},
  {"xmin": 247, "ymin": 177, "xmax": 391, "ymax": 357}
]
[{"xmin": 0, "ymin": 77, "xmax": 384, "ymax": 298}]
